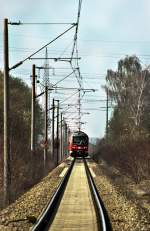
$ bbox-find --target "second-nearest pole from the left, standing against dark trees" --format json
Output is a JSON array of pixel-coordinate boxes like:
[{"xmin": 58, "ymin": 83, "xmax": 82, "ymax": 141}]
[{"xmin": 31, "ymin": 65, "xmax": 35, "ymax": 153}]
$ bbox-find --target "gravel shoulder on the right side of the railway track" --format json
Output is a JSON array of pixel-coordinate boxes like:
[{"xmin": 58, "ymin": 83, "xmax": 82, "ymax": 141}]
[{"xmin": 90, "ymin": 162, "xmax": 150, "ymax": 231}]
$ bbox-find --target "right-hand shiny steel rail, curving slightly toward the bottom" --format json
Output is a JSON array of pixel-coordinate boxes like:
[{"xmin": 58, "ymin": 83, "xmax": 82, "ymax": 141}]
[{"xmin": 84, "ymin": 159, "xmax": 112, "ymax": 231}]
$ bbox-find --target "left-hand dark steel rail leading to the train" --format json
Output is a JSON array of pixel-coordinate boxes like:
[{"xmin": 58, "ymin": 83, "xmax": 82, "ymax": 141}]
[{"xmin": 31, "ymin": 159, "xmax": 75, "ymax": 231}]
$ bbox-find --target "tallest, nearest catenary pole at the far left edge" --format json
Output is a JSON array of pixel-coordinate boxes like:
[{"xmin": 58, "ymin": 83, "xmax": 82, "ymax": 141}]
[{"xmin": 4, "ymin": 19, "xmax": 11, "ymax": 206}]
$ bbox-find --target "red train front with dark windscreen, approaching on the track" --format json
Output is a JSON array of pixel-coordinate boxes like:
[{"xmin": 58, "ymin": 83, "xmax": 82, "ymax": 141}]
[{"xmin": 69, "ymin": 131, "xmax": 89, "ymax": 157}]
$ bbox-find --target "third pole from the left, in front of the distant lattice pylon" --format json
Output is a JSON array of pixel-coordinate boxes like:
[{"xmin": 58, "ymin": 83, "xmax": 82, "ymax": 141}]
[{"xmin": 44, "ymin": 86, "xmax": 48, "ymax": 170}]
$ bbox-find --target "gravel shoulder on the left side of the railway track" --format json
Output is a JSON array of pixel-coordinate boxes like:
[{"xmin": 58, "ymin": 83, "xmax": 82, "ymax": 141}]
[{"xmin": 0, "ymin": 162, "xmax": 67, "ymax": 231}]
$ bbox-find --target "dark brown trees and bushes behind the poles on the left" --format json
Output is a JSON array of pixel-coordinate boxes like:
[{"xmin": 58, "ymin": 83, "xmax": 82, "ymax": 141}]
[{"xmin": 0, "ymin": 72, "xmax": 53, "ymax": 208}]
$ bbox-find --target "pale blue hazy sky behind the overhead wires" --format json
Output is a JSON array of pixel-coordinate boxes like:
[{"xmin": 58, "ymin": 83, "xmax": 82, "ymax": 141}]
[{"xmin": 0, "ymin": 0, "xmax": 150, "ymax": 137}]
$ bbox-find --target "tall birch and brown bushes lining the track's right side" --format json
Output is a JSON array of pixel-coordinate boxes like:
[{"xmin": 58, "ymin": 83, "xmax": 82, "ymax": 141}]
[{"xmin": 95, "ymin": 56, "xmax": 150, "ymax": 183}]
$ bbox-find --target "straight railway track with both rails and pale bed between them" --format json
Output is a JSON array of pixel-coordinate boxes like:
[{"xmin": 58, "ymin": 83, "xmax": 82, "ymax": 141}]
[{"xmin": 32, "ymin": 159, "xmax": 112, "ymax": 231}]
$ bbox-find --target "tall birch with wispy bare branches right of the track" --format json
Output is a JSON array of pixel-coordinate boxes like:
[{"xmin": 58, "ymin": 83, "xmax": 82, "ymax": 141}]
[{"xmin": 106, "ymin": 56, "xmax": 150, "ymax": 140}]
